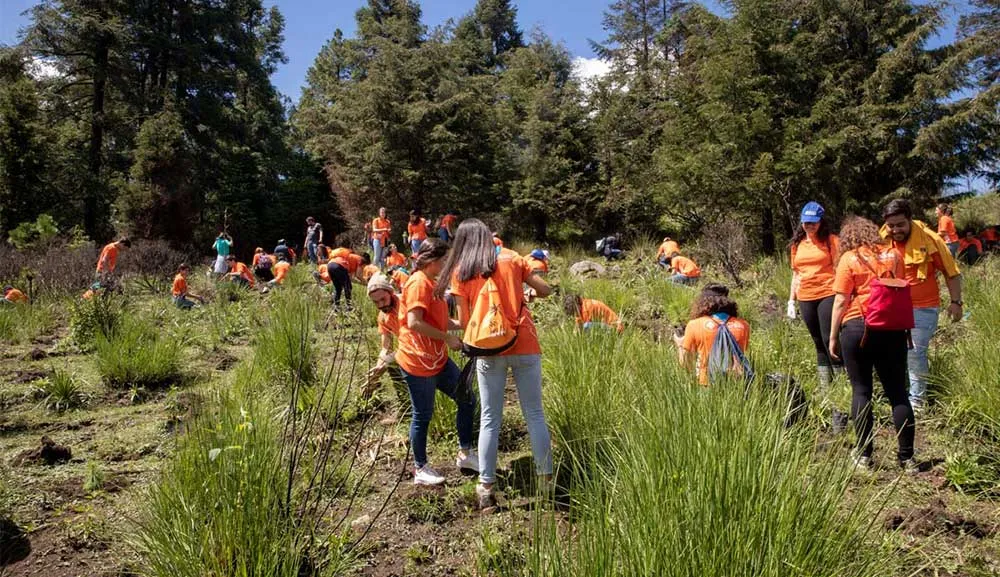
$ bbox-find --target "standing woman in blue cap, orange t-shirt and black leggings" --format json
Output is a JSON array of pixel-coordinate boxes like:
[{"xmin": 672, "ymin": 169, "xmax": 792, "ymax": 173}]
[{"xmin": 788, "ymin": 202, "xmax": 842, "ymax": 410}]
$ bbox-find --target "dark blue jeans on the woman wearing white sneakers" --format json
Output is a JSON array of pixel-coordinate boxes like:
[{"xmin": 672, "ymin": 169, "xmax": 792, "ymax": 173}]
[{"xmin": 401, "ymin": 359, "xmax": 476, "ymax": 469}]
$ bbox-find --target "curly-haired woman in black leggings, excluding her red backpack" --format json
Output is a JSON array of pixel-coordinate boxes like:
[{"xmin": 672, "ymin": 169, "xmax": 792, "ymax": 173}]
[{"xmin": 830, "ymin": 217, "xmax": 916, "ymax": 472}]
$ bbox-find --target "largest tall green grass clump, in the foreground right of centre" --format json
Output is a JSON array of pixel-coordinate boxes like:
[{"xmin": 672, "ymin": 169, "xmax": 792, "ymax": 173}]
[{"xmin": 528, "ymin": 334, "xmax": 895, "ymax": 577}]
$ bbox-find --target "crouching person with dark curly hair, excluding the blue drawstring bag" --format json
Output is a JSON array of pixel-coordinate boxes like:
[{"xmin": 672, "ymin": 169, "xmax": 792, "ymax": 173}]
[{"xmin": 674, "ymin": 284, "xmax": 750, "ymax": 387}]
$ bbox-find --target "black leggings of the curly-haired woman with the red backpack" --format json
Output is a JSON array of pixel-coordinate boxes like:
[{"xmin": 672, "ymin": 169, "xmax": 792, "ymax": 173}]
[{"xmin": 840, "ymin": 319, "xmax": 916, "ymax": 461}]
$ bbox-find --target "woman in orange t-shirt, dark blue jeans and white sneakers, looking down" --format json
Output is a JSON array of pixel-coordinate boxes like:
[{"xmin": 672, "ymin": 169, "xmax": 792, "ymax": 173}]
[{"xmin": 396, "ymin": 238, "xmax": 479, "ymax": 485}]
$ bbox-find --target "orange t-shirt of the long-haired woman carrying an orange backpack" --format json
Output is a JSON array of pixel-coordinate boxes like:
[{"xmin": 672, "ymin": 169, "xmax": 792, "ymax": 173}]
[{"xmin": 451, "ymin": 250, "xmax": 542, "ymax": 355}]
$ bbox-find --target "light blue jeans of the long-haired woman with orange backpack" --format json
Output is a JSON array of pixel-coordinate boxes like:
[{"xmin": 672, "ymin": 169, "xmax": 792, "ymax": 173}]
[{"xmin": 476, "ymin": 355, "xmax": 552, "ymax": 483}]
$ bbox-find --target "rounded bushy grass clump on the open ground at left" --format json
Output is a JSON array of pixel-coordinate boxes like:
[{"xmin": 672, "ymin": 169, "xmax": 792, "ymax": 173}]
[{"xmin": 94, "ymin": 317, "xmax": 183, "ymax": 389}]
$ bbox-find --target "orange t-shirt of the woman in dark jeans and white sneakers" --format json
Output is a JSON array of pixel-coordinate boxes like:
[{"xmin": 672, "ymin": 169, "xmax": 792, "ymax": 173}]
[{"xmin": 396, "ymin": 271, "xmax": 448, "ymax": 377}]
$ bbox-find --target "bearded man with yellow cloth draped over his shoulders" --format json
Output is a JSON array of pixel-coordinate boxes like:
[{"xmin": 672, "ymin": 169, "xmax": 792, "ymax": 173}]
[{"xmin": 880, "ymin": 199, "xmax": 963, "ymax": 411}]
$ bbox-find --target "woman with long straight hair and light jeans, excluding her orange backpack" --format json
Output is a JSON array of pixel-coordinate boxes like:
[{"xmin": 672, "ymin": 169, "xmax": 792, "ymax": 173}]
[{"xmin": 435, "ymin": 219, "xmax": 552, "ymax": 509}]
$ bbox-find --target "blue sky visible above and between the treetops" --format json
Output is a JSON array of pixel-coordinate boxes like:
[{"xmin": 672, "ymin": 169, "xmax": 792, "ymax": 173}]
[{"xmin": 0, "ymin": 0, "xmax": 965, "ymax": 100}]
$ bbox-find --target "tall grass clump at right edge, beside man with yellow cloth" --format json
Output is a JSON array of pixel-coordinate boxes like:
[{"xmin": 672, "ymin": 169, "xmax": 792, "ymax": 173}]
[{"xmin": 931, "ymin": 258, "xmax": 1000, "ymax": 438}]
